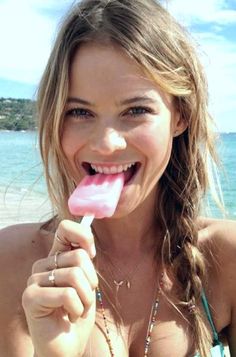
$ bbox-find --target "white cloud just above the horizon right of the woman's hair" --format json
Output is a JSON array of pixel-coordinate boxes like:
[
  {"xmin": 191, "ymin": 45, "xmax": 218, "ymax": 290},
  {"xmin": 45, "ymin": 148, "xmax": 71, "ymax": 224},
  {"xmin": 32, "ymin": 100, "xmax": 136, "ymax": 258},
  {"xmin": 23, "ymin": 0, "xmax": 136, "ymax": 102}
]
[{"xmin": 199, "ymin": 33, "xmax": 236, "ymax": 131}]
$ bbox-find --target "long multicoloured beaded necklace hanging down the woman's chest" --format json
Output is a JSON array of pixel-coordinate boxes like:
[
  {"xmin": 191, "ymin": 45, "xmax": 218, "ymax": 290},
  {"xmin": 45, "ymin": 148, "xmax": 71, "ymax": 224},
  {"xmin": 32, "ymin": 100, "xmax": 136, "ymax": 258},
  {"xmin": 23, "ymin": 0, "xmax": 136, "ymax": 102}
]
[{"xmin": 96, "ymin": 273, "xmax": 163, "ymax": 357}]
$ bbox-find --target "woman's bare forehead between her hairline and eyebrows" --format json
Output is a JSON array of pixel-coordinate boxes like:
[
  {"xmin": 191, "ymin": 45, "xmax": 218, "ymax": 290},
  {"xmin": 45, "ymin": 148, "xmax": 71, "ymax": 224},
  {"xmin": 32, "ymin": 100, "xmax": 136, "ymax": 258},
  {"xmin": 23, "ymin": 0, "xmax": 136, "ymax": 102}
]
[{"xmin": 69, "ymin": 42, "xmax": 171, "ymax": 105}]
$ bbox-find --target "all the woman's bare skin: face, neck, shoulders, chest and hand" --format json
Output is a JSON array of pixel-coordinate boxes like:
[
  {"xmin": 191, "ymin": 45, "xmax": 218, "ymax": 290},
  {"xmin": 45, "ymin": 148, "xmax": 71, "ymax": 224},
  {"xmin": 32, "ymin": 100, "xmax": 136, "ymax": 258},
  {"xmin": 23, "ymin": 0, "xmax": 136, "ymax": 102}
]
[{"xmin": 0, "ymin": 44, "xmax": 236, "ymax": 357}]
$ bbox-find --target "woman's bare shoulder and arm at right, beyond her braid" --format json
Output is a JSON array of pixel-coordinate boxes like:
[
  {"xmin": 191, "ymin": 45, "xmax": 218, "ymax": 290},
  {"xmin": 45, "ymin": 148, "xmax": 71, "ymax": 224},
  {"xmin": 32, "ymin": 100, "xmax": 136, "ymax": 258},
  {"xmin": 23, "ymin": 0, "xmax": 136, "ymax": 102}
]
[{"xmin": 199, "ymin": 219, "xmax": 236, "ymax": 356}]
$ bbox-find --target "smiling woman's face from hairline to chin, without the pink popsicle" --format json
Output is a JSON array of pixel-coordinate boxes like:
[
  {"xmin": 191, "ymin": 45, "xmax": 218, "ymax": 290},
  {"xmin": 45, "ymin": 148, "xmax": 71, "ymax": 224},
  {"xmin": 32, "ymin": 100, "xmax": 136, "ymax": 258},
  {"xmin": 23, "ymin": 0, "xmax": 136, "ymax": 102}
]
[{"xmin": 62, "ymin": 43, "xmax": 182, "ymax": 216}]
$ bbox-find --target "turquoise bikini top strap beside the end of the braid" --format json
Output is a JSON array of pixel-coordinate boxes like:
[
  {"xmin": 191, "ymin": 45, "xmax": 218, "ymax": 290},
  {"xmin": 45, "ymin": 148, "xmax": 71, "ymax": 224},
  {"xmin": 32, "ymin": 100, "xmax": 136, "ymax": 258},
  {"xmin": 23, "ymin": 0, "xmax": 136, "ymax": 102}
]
[{"xmin": 193, "ymin": 291, "xmax": 224, "ymax": 357}]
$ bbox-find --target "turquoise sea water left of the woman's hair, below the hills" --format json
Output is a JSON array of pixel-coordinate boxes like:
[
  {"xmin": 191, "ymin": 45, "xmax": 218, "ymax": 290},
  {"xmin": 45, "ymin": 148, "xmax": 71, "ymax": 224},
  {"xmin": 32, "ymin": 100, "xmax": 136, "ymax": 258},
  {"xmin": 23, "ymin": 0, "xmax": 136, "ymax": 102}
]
[{"xmin": 0, "ymin": 131, "xmax": 52, "ymax": 228}]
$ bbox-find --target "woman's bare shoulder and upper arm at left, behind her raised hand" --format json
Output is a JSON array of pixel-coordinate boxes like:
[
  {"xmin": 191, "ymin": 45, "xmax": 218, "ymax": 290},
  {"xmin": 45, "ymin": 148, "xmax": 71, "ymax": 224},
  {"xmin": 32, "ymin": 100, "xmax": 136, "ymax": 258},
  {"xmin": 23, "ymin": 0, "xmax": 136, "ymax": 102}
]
[{"xmin": 0, "ymin": 224, "xmax": 52, "ymax": 357}]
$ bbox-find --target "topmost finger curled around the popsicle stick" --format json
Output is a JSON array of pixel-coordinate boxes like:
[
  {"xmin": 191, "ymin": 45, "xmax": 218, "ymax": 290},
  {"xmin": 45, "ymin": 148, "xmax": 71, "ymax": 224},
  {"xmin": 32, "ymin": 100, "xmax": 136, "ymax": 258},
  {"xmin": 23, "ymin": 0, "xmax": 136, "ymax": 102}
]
[{"xmin": 49, "ymin": 220, "xmax": 96, "ymax": 258}]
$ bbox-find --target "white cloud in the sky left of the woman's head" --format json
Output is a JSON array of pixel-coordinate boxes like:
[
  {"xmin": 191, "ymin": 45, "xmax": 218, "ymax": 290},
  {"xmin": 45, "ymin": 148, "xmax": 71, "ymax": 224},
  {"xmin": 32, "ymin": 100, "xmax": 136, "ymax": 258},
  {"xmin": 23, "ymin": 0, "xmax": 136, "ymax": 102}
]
[{"xmin": 0, "ymin": 0, "xmax": 71, "ymax": 83}]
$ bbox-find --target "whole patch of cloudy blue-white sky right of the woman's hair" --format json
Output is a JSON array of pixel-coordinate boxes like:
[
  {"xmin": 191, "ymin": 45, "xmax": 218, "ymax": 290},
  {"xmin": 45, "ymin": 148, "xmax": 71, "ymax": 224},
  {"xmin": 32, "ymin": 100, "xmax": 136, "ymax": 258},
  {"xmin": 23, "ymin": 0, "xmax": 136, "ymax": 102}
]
[{"xmin": 162, "ymin": 0, "xmax": 236, "ymax": 131}]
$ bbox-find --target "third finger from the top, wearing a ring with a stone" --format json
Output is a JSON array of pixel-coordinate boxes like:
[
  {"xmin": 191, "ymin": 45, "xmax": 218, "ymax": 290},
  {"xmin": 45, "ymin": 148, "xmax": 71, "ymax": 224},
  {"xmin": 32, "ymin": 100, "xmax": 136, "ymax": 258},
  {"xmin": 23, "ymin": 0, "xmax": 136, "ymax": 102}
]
[{"xmin": 28, "ymin": 267, "xmax": 94, "ymax": 313}]
